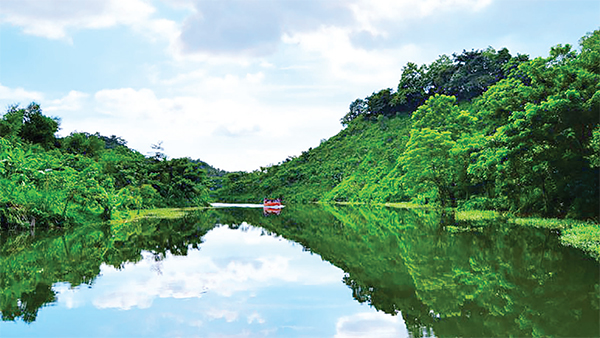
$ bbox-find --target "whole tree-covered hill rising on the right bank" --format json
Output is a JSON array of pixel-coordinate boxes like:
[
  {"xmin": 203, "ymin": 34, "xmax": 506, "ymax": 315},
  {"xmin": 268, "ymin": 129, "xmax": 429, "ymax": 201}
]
[{"xmin": 217, "ymin": 30, "xmax": 600, "ymax": 218}]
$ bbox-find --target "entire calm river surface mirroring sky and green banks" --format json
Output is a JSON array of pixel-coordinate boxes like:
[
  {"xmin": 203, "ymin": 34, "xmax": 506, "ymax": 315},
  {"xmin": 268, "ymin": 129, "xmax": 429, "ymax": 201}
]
[{"xmin": 0, "ymin": 206, "xmax": 600, "ymax": 337}]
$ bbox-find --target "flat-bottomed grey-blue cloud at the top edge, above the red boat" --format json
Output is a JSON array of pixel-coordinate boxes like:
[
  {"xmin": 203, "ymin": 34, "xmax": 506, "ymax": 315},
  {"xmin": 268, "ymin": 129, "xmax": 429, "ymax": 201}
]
[{"xmin": 173, "ymin": 0, "xmax": 352, "ymax": 56}]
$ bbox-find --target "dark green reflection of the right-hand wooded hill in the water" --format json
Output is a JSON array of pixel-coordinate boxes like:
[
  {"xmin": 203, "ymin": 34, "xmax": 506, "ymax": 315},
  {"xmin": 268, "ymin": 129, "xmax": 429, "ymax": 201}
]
[{"xmin": 220, "ymin": 206, "xmax": 600, "ymax": 337}]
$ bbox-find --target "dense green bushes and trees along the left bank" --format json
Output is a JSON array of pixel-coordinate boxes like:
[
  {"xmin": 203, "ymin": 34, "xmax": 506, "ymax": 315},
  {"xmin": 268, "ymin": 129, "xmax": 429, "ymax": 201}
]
[{"xmin": 0, "ymin": 103, "xmax": 210, "ymax": 229}]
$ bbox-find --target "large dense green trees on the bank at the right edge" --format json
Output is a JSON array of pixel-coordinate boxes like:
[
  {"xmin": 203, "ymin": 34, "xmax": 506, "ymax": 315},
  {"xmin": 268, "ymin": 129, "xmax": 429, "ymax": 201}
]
[{"xmin": 469, "ymin": 31, "xmax": 600, "ymax": 217}]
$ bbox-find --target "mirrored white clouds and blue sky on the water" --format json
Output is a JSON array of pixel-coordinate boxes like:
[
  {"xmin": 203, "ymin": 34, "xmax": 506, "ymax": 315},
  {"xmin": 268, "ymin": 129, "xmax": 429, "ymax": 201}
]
[{"xmin": 47, "ymin": 224, "xmax": 403, "ymax": 337}]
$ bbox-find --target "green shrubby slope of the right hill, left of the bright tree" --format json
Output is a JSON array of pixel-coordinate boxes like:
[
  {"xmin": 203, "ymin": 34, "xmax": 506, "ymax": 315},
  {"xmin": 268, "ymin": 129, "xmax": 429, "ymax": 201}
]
[{"xmin": 217, "ymin": 116, "xmax": 410, "ymax": 203}]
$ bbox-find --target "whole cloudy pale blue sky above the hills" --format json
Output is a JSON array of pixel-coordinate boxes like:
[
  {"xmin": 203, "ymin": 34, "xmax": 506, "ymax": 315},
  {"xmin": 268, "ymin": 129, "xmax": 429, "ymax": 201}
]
[{"xmin": 0, "ymin": 0, "xmax": 600, "ymax": 170}]
